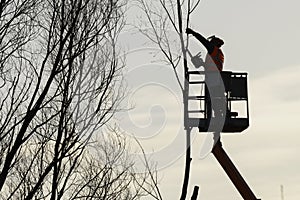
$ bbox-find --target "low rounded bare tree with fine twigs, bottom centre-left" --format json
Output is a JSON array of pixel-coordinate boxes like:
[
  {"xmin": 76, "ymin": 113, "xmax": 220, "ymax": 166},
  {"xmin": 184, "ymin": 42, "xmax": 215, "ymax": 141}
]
[{"xmin": 68, "ymin": 132, "xmax": 162, "ymax": 200}]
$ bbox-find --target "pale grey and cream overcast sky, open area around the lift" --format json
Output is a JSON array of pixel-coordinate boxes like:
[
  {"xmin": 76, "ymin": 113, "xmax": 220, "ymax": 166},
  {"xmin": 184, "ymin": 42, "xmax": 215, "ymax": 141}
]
[{"xmin": 121, "ymin": 0, "xmax": 300, "ymax": 200}]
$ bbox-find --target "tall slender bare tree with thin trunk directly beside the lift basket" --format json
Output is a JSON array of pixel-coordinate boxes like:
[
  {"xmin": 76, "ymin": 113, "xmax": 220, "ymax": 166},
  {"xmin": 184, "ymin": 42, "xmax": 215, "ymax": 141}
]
[{"xmin": 136, "ymin": 0, "xmax": 200, "ymax": 200}]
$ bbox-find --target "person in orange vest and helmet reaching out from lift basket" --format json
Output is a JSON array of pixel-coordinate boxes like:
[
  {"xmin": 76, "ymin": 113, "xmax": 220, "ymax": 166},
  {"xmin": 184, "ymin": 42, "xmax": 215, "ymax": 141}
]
[{"xmin": 186, "ymin": 28, "xmax": 226, "ymax": 131}]
